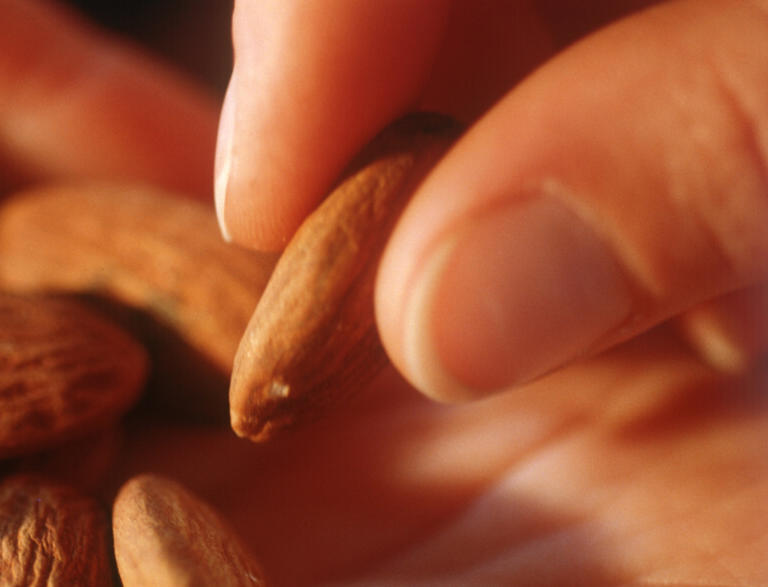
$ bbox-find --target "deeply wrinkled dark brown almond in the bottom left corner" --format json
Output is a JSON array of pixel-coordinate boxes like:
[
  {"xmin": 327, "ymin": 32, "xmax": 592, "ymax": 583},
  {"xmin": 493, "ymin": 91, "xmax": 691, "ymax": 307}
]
[{"xmin": 0, "ymin": 475, "xmax": 112, "ymax": 587}]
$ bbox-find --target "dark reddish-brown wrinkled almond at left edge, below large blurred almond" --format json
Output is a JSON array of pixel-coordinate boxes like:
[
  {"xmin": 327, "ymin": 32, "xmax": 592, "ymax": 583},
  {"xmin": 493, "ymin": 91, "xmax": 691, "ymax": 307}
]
[{"xmin": 0, "ymin": 294, "xmax": 147, "ymax": 457}]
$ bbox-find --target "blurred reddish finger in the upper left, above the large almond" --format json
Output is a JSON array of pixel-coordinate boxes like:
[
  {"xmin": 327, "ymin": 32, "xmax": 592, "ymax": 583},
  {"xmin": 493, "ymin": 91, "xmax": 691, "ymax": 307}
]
[{"xmin": 0, "ymin": 0, "xmax": 217, "ymax": 201}]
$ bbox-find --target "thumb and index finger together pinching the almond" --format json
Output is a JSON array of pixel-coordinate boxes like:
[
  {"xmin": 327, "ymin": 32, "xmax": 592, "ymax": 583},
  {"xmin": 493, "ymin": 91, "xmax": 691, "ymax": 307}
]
[{"xmin": 217, "ymin": 1, "xmax": 768, "ymax": 399}]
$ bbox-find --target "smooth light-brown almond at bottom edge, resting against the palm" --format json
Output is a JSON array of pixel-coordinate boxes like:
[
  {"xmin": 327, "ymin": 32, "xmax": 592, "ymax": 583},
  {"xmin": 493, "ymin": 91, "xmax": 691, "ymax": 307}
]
[{"xmin": 112, "ymin": 475, "xmax": 266, "ymax": 587}]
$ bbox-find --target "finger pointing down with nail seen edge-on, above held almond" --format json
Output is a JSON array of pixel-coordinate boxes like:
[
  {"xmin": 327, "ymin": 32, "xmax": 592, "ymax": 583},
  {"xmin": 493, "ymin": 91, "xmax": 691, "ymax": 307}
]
[{"xmin": 216, "ymin": 0, "xmax": 450, "ymax": 249}]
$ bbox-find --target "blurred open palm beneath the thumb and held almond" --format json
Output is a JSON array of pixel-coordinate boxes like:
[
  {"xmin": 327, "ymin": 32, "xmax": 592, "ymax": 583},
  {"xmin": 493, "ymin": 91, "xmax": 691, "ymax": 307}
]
[{"xmin": 121, "ymin": 329, "xmax": 768, "ymax": 587}]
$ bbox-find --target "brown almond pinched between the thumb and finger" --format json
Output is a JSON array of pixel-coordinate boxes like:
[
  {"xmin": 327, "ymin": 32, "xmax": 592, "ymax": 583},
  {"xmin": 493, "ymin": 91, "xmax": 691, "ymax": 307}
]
[{"xmin": 230, "ymin": 114, "xmax": 458, "ymax": 440}]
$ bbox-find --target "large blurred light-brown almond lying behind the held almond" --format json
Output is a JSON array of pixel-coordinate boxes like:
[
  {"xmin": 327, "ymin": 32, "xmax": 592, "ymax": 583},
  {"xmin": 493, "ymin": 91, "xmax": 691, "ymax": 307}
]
[{"xmin": 0, "ymin": 183, "xmax": 276, "ymax": 422}]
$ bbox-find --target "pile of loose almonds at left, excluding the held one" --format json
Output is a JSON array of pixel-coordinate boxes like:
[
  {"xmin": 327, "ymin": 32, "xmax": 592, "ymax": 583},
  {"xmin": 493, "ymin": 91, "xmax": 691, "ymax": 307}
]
[{"xmin": 0, "ymin": 184, "xmax": 274, "ymax": 586}]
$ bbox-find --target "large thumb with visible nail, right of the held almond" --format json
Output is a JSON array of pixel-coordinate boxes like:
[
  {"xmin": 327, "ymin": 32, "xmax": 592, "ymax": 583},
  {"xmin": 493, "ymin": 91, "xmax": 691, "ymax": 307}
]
[{"xmin": 376, "ymin": 1, "xmax": 768, "ymax": 399}]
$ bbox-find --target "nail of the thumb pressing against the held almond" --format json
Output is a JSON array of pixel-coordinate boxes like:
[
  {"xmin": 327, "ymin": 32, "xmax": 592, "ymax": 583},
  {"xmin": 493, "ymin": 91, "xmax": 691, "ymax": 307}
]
[{"xmin": 403, "ymin": 195, "xmax": 631, "ymax": 400}]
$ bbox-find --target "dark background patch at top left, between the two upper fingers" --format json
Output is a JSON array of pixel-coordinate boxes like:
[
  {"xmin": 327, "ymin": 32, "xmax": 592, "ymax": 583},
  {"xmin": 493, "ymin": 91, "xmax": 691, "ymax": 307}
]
[{"xmin": 62, "ymin": 0, "xmax": 233, "ymax": 95}]
